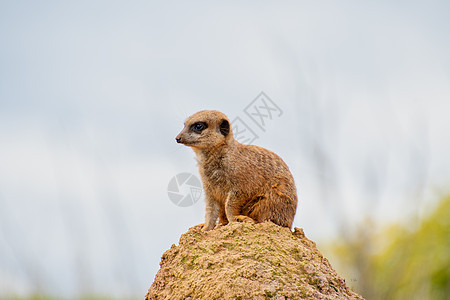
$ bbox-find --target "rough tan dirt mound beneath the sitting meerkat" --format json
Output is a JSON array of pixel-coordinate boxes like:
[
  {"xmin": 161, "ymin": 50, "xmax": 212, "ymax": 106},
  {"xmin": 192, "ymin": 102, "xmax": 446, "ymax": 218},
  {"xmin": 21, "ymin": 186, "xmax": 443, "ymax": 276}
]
[{"xmin": 146, "ymin": 222, "xmax": 363, "ymax": 300}]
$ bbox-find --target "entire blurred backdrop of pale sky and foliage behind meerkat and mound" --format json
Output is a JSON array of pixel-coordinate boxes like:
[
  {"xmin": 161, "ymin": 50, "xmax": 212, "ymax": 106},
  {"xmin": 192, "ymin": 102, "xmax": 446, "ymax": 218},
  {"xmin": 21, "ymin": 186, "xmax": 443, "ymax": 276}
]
[{"xmin": 0, "ymin": 0, "xmax": 450, "ymax": 299}]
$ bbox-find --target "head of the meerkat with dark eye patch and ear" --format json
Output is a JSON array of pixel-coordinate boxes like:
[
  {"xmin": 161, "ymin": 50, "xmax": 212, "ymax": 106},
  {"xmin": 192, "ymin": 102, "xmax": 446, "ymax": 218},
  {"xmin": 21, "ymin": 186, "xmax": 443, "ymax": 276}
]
[{"xmin": 176, "ymin": 110, "xmax": 233, "ymax": 149}]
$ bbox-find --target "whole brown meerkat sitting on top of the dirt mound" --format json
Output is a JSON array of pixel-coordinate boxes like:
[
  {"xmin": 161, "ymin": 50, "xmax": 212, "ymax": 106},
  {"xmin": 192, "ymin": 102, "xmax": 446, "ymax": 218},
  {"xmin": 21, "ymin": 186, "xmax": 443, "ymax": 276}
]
[{"xmin": 176, "ymin": 110, "xmax": 297, "ymax": 230}]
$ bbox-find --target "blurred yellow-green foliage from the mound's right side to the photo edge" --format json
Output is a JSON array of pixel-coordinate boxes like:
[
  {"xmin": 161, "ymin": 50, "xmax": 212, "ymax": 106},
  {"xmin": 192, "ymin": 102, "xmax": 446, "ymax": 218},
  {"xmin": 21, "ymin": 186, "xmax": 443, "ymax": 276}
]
[{"xmin": 332, "ymin": 196, "xmax": 450, "ymax": 300}]
